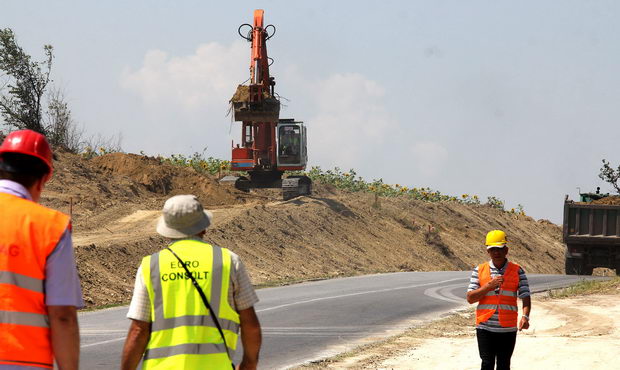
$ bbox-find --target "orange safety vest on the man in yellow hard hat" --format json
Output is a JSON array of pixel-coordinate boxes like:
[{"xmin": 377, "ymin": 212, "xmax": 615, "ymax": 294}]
[{"xmin": 476, "ymin": 262, "xmax": 520, "ymax": 327}]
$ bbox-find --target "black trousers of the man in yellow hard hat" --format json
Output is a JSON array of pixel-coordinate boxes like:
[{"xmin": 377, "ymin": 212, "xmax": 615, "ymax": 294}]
[{"xmin": 476, "ymin": 329, "xmax": 517, "ymax": 370}]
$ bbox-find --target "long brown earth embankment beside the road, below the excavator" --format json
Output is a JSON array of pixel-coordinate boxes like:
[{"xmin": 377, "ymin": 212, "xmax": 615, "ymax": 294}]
[{"xmin": 42, "ymin": 153, "xmax": 564, "ymax": 306}]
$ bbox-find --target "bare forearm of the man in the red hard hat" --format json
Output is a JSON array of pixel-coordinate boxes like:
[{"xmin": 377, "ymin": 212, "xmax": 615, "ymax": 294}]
[{"xmin": 47, "ymin": 306, "xmax": 80, "ymax": 370}]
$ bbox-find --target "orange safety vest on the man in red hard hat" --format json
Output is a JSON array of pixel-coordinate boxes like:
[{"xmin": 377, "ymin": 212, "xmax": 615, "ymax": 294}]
[{"xmin": 0, "ymin": 193, "xmax": 69, "ymax": 368}]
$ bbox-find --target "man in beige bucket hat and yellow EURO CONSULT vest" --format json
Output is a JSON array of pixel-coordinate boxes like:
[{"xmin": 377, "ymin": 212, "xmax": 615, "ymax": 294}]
[{"xmin": 121, "ymin": 195, "xmax": 261, "ymax": 370}]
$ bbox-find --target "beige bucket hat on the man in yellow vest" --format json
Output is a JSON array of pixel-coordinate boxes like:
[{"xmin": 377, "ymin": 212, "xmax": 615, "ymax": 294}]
[{"xmin": 157, "ymin": 195, "xmax": 213, "ymax": 239}]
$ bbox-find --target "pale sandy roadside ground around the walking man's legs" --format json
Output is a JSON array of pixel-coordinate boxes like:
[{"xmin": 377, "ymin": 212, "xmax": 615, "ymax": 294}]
[{"xmin": 305, "ymin": 288, "xmax": 620, "ymax": 370}]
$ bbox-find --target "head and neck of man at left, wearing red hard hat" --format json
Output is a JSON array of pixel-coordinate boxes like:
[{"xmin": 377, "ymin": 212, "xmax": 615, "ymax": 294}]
[{"xmin": 0, "ymin": 130, "xmax": 52, "ymax": 201}]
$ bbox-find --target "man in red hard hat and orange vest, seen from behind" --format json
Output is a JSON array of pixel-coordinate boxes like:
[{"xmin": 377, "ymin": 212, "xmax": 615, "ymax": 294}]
[{"xmin": 0, "ymin": 130, "xmax": 83, "ymax": 370}]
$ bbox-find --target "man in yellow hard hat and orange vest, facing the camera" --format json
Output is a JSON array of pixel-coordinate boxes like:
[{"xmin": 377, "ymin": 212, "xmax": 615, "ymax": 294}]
[{"xmin": 467, "ymin": 230, "xmax": 532, "ymax": 370}]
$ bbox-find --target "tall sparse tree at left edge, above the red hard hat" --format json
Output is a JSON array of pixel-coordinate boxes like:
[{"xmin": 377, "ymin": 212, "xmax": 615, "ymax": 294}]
[{"xmin": 0, "ymin": 28, "xmax": 54, "ymax": 134}]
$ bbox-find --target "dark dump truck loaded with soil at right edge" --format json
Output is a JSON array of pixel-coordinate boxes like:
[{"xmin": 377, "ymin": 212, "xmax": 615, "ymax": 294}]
[{"xmin": 562, "ymin": 192, "xmax": 620, "ymax": 276}]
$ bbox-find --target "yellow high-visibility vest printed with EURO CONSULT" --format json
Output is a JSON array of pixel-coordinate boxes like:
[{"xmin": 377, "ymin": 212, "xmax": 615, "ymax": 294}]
[{"xmin": 142, "ymin": 240, "xmax": 240, "ymax": 370}]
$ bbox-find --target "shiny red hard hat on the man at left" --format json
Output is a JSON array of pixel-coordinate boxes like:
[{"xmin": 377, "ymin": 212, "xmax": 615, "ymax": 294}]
[{"xmin": 0, "ymin": 130, "xmax": 52, "ymax": 175}]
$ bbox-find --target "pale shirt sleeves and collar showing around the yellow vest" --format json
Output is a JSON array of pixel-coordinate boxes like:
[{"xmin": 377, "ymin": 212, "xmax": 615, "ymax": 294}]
[{"xmin": 127, "ymin": 237, "xmax": 258, "ymax": 322}]
